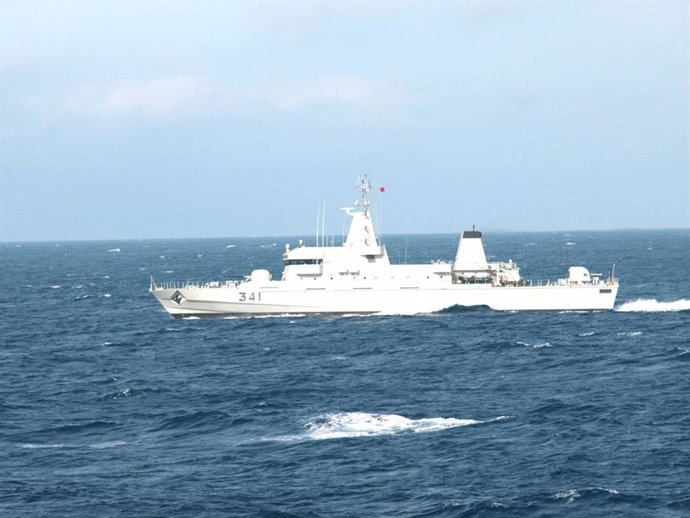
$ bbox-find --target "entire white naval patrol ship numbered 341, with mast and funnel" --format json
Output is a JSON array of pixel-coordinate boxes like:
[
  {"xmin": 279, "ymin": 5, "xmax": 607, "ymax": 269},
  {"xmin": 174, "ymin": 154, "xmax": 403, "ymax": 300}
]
[{"xmin": 150, "ymin": 179, "xmax": 618, "ymax": 317}]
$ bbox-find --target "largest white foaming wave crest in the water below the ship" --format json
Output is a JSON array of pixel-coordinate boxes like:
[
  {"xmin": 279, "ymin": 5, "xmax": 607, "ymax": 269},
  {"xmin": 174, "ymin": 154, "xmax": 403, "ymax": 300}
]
[{"xmin": 279, "ymin": 412, "xmax": 508, "ymax": 441}]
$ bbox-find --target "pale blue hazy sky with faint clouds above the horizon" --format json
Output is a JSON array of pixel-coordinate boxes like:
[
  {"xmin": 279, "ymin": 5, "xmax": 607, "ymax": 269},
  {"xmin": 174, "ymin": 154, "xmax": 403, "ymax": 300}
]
[{"xmin": 0, "ymin": 0, "xmax": 690, "ymax": 241}]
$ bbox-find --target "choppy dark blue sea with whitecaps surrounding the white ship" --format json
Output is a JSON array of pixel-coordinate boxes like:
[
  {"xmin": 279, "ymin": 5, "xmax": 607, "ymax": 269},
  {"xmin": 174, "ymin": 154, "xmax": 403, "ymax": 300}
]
[{"xmin": 0, "ymin": 229, "xmax": 690, "ymax": 518}]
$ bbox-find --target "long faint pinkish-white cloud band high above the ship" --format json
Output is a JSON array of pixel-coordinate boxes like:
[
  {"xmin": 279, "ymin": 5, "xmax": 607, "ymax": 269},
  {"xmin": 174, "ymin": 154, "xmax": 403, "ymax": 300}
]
[{"xmin": 31, "ymin": 76, "xmax": 414, "ymax": 123}]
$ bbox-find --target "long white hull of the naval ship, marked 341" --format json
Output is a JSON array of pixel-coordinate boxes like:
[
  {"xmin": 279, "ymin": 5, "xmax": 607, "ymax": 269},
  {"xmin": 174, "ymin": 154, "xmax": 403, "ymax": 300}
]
[{"xmin": 151, "ymin": 281, "xmax": 618, "ymax": 318}]
